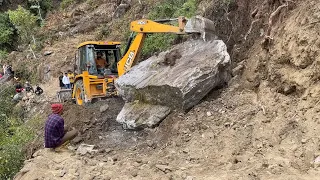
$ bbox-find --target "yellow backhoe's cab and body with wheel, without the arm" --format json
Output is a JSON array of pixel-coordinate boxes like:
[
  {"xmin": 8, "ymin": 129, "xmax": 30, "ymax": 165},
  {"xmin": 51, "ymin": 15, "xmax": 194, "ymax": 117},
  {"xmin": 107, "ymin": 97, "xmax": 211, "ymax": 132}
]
[{"xmin": 72, "ymin": 41, "xmax": 121, "ymax": 105}]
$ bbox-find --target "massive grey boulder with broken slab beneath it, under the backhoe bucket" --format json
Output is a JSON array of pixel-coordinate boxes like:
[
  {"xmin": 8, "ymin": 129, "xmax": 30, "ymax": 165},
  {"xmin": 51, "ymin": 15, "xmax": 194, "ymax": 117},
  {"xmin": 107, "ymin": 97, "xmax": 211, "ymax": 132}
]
[{"xmin": 116, "ymin": 40, "xmax": 230, "ymax": 129}]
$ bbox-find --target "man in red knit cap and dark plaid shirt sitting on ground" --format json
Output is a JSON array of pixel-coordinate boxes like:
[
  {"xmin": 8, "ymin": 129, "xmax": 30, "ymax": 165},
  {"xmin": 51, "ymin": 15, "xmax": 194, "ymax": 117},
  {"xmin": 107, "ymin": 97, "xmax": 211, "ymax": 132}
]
[{"xmin": 45, "ymin": 104, "xmax": 78, "ymax": 148}]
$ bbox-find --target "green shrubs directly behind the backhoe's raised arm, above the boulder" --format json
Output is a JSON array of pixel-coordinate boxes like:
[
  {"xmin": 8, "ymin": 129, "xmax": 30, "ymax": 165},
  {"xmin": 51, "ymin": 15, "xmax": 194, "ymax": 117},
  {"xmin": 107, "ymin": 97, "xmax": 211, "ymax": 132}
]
[{"xmin": 142, "ymin": 0, "xmax": 198, "ymax": 57}]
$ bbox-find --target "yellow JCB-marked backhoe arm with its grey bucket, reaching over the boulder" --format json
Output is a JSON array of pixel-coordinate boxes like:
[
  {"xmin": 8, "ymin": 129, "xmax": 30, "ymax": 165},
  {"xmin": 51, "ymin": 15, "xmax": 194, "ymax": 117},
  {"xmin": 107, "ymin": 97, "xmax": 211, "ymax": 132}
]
[{"xmin": 118, "ymin": 16, "xmax": 214, "ymax": 76}]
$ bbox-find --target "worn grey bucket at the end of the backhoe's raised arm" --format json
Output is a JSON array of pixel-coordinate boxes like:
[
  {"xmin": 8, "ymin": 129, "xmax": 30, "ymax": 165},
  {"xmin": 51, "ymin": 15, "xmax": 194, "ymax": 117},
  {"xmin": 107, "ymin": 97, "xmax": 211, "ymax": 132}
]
[{"xmin": 184, "ymin": 16, "xmax": 217, "ymax": 41}]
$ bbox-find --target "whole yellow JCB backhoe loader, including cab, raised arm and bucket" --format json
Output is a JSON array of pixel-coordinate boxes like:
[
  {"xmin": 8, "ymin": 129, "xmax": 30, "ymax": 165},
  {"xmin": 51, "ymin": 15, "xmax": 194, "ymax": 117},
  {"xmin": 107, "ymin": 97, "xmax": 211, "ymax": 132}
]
[{"xmin": 58, "ymin": 16, "xmax": 214, "ymax": 105}]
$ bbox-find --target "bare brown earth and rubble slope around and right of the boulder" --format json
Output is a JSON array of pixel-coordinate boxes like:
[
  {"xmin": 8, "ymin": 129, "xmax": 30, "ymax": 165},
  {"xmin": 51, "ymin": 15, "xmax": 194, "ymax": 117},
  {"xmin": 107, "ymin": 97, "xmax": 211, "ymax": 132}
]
[{"xmin": 16, "ymin": 0, "xmax": 320, "ymax": 180}]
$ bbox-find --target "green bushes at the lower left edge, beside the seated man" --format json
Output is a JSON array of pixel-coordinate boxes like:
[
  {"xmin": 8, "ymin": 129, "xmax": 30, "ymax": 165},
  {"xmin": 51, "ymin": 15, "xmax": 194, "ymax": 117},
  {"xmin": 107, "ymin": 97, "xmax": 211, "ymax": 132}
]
[{"xmin": 0, "ymin": 85, "xmax": 41, "ymax": 179}]
